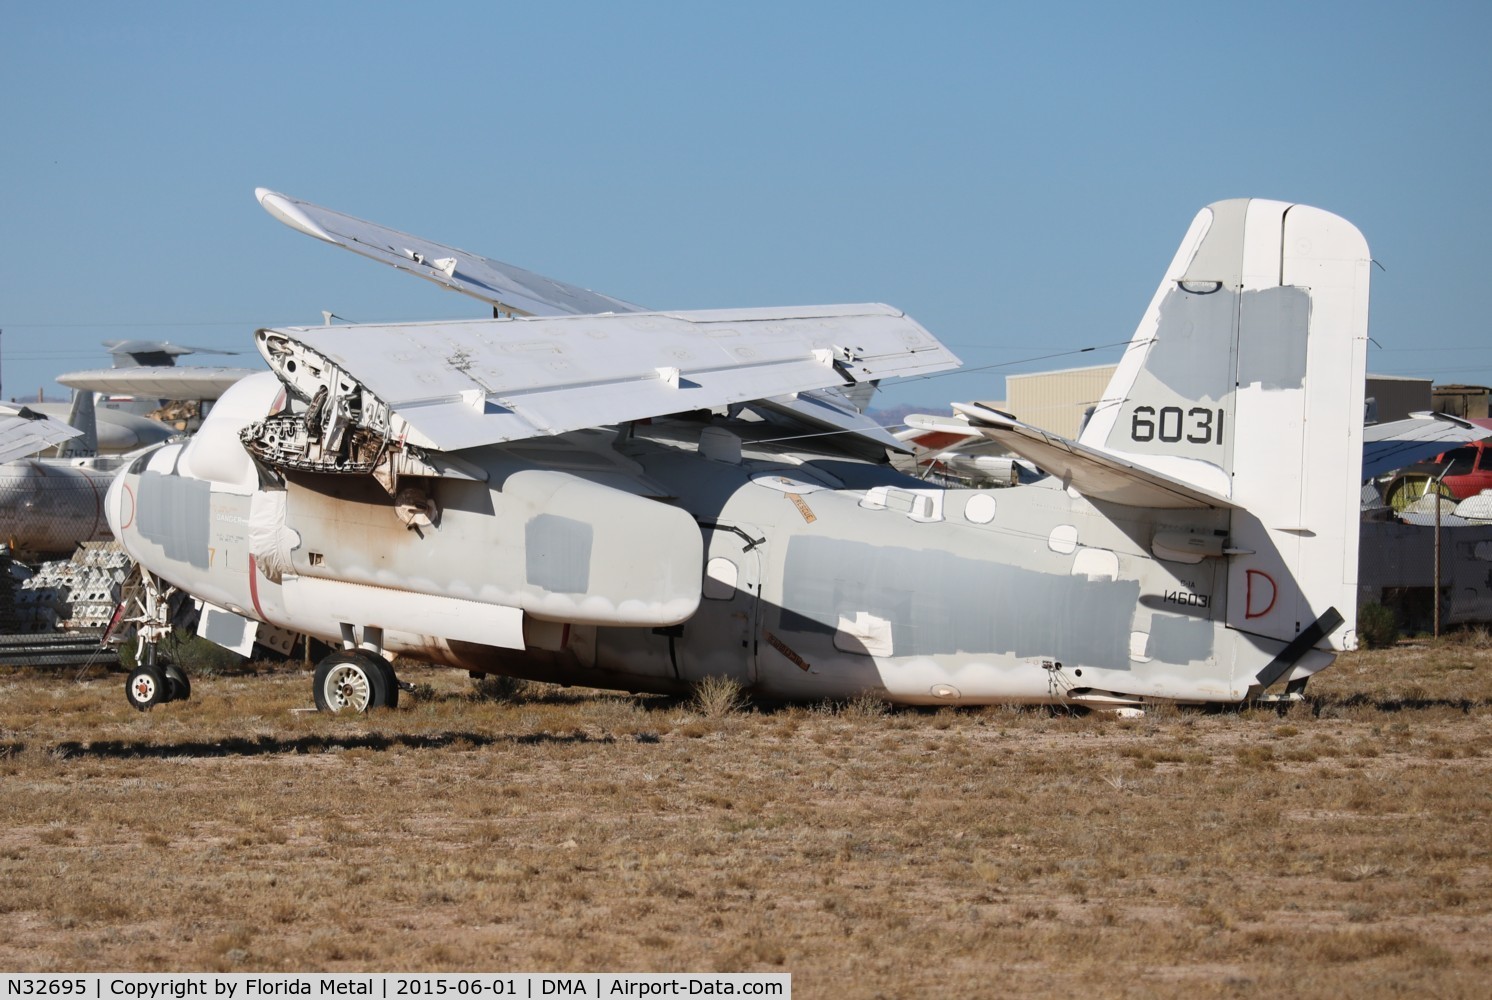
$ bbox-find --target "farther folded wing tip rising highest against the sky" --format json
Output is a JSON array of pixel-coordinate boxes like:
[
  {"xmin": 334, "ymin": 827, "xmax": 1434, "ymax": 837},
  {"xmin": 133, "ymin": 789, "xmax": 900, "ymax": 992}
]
[{"xmin": 254, "ymin": 188, "xmax": 643, "ymax": 316}]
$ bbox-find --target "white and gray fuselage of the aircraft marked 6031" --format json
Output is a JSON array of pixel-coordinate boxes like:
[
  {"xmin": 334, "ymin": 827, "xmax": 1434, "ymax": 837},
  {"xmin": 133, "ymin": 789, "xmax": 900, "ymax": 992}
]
[{"xmin": 110, "ymin": 418, "xmax": 1329, "ymax": 704}]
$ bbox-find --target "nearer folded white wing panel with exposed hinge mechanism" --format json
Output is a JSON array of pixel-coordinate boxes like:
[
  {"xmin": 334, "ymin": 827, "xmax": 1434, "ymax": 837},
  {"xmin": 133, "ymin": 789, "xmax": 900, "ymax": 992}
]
[{"xmin": 257, "ymin": 304, "xmax": 958, "ymax": 451}]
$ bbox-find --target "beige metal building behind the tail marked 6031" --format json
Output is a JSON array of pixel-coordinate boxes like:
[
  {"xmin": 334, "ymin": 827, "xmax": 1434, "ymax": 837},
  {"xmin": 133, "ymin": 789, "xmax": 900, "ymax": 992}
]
[{"xmin": 1000, "ymin": 364, "xmax": 1431, "ymax": 437}]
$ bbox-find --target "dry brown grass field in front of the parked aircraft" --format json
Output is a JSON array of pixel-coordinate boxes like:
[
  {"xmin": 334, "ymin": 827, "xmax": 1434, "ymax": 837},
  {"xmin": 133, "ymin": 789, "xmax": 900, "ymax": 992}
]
[{"xmin": 0, "ymin": 640, "xmax": 1492, "ymax": 997}]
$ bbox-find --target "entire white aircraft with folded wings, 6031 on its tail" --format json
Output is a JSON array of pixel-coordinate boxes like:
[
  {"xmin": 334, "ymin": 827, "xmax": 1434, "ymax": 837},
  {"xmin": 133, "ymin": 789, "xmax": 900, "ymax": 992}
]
[{"xmin": 106, "ymin": 190, "xmax": 1370, "ymax": 710}]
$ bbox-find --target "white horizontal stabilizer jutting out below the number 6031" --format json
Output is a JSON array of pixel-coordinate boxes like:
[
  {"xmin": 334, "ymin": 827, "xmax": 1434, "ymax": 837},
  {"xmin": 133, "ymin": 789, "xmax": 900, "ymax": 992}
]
[{"xmin": 954, "ymin": 403, "xmax": 1234, "ymax": 509}]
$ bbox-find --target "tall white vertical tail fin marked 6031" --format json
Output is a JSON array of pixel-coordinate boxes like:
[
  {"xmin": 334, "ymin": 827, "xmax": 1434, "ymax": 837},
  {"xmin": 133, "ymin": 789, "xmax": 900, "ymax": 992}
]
[{"xmin": 1080, "ymin": 200, "xmax": 1371, "ymax": 649}]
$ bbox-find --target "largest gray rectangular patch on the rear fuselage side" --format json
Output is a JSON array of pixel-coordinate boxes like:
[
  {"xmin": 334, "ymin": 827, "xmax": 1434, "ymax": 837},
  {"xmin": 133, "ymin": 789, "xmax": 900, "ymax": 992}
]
[{"xmin": 782, "ymin": 536, "xmax": 1140, "ymax": 670}]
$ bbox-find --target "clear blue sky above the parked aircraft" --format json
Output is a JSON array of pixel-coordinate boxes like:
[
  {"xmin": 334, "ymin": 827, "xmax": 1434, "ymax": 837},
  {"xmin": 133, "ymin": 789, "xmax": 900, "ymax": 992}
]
[{"xmin": 0, "ymin": 0, "xmax": 1492, "ymax": 407}]
